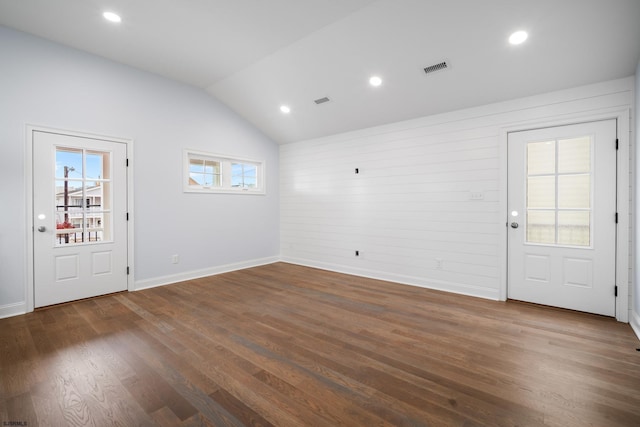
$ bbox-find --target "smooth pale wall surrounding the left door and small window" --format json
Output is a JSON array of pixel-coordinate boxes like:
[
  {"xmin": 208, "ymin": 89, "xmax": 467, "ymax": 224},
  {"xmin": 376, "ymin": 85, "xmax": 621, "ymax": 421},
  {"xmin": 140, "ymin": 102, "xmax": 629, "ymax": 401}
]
[{"xmin": 0, "ymin": 27, "xmax": 279, "ymax": 317}]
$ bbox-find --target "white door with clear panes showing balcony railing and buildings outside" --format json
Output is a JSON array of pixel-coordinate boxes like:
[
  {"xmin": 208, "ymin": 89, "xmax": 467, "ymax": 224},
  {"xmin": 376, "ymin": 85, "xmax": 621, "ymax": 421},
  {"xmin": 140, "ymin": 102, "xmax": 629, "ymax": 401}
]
[{"xmin": 32, "ymin": 131, "xmax": 127, "ymax": 307}]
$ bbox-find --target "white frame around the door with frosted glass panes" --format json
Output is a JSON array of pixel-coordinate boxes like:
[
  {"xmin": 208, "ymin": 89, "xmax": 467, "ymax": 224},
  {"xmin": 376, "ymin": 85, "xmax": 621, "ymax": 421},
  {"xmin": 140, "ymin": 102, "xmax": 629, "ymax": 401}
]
[{"xmin": 500, "ymin": 108, "xmax": 631, "ymax": 323}]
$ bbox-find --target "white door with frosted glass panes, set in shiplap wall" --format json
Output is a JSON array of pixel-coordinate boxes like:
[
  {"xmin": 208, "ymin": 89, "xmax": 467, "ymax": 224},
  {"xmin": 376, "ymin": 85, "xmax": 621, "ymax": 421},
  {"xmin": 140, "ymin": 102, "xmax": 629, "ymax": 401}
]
[{"xmin": 508, "ymin": 120, "xmax": 616, "ymax": 316}]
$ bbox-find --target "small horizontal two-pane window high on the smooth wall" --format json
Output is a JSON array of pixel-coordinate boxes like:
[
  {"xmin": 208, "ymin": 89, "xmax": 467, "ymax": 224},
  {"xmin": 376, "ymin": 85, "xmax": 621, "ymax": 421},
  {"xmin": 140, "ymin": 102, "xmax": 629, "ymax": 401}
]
[{"xmin": 183, "ymin": 150, "xmax": 265, "ymax": 194}]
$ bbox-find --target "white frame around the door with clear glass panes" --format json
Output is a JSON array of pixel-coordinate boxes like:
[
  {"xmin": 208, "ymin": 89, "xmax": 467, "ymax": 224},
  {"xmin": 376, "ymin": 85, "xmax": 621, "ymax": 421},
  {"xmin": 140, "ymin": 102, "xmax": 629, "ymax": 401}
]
[{"xmin": 25, "ymin": 125, "xmax": 135, "ymax": 312}]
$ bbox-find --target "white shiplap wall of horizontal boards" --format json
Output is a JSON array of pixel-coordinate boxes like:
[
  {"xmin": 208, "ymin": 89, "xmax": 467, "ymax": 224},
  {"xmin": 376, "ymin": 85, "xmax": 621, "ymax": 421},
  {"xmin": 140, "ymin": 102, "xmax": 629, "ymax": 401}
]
[{"xmin": 280, "ymin": 77, "xmax": 634, "ymax": 299}]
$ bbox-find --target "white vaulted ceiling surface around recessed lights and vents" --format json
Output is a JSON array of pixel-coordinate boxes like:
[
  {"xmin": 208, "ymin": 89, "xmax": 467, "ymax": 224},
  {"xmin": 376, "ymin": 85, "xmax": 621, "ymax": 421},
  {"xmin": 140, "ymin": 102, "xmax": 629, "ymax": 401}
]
[{"xmin": 0, "ymin": 0, "xmax": 640, "ymax": 143}]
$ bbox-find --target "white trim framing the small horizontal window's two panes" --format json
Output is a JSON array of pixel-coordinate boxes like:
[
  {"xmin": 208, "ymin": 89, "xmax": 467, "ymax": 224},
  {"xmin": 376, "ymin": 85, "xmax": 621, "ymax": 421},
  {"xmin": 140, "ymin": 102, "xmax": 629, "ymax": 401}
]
[{"xmin": 182, "ymin": 148, "xmax": 267, "ymax": 195}]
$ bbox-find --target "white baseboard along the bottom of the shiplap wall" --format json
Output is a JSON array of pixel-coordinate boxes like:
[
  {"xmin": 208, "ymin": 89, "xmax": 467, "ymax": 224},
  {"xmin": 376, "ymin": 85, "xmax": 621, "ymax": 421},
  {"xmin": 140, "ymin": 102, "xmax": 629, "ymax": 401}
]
[{"xmin": 280, "ymin": 257, "xmax": 500, "ymax": 301}]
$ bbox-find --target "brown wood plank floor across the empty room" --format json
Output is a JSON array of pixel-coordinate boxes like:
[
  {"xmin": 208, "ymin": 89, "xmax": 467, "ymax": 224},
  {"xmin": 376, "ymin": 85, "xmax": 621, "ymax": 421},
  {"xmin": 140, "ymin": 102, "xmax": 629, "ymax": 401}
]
[{"xmin": 0, "ymin": 263, "xmax": 640, "ymax": 427}]
